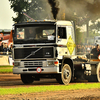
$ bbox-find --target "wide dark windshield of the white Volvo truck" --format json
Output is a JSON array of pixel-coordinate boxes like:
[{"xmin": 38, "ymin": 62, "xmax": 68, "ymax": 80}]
[{"xmin": 14, "ymin": 25, "xmax": 56, "ymax": 44}]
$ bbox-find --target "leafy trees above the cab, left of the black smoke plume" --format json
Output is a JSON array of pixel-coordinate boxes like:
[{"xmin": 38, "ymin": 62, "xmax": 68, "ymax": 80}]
[{"xmin": 9, "ymin": 0, "xmax": 48, "ymax": 22}]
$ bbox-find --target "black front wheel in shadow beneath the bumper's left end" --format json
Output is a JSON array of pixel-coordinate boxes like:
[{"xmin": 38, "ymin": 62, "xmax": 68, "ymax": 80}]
[{"xmin": 21, "ymin": 74, "xmax": 34, "ymax": 84}]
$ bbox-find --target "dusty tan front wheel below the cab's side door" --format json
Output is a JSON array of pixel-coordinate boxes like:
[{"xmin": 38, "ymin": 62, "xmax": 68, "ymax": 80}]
[{"xmin": 61, "ymin": 64, "xmax": 72, "ymax": 85}]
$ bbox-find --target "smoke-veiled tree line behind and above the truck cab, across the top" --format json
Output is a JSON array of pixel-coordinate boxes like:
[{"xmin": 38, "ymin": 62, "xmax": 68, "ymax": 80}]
[{"xmin": 9, "ymin": 0, "xmax": 100, "ymax": 44}]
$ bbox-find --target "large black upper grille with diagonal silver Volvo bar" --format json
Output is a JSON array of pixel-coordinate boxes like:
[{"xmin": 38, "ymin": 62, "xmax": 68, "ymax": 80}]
[{"xmin": 14, "ymin": 47, "xmax": 54, "ymax": 59}]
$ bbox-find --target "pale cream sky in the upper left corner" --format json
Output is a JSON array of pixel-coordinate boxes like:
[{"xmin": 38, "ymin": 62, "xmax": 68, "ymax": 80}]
[{"xmin": 0, "ymin": 0, "xmax": 16, "ymax": 29}]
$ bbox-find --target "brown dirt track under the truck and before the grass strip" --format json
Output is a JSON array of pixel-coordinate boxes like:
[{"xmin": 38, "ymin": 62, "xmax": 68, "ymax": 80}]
[{"xmin": 0, "ymin": 74, "xmax": 100, "ymax": 100}]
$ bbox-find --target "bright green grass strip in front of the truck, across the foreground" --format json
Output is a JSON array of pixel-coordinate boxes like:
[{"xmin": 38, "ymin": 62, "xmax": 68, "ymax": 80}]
[{"xmin": 0, "ymin": 83, "xmax": 100, "ymax": 95}]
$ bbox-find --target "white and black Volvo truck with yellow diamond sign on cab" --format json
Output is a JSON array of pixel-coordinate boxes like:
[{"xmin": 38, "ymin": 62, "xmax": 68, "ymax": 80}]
[{"xmin": 12, "ymin": 20, "xmax": 100, "ymax": 85}]
